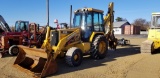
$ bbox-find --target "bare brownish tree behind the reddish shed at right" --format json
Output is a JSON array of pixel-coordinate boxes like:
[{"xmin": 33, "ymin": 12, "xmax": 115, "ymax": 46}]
[{"xmin": 132, "ymin": 18, "xmax": 150, "ymax": 30}]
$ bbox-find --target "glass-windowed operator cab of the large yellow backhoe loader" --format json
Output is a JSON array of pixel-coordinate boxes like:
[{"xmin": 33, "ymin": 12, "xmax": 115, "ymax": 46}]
[{"xmin": 73, "ymin": 8, "xmax": 104, "ymax": 41}]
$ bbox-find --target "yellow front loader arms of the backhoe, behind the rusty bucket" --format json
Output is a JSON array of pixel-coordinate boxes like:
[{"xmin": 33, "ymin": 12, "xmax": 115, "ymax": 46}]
[{"xmin": 41, "ymin": 26, "xmax": 80, "ymax": 59}]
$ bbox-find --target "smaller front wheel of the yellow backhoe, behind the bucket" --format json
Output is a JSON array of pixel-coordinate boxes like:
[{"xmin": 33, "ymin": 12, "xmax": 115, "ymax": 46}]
[{"xmin": 65, "ymin": 47, "xmax": 83, "ymax": 67}]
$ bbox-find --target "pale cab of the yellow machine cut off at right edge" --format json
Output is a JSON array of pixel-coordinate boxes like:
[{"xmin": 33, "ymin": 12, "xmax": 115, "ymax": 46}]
[{"xmin": 151, "ymin": 13, "xmax": 160, "ymax": 28}]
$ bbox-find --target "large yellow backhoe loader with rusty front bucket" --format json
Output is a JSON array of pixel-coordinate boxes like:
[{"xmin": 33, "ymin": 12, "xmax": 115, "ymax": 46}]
[{"xmin": 14, "ymin": 2, "xmax": 115, "ymax": 77}]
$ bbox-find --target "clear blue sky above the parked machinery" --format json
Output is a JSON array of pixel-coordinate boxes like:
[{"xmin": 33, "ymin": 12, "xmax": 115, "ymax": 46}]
[{"xmin": 0, "ymin": 0, "xmax": 160, "ymax": 27}]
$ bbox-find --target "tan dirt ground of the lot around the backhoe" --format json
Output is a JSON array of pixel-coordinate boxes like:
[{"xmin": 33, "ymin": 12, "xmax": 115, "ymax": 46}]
[{"xmin": 0, "ymin": 36, "xmax": 160, "ymax": 78}]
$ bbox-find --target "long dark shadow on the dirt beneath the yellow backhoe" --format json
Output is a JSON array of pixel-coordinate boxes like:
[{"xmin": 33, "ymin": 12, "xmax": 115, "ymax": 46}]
[{"xmin": 47, "ymin": 45, "xmax": 140, "ymax": 77}]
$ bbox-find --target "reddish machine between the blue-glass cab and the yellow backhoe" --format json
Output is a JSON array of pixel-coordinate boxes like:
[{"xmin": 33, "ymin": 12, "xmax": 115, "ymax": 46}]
[{"xmin": 22, "ymin": 23, "xmax": 45, "ymax": 48}]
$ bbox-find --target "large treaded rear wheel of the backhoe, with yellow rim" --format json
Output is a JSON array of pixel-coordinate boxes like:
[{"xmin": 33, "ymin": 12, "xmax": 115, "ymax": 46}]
[{"xmin": 91, "ymin": 35, "xmax": 108, "ymax": 59}]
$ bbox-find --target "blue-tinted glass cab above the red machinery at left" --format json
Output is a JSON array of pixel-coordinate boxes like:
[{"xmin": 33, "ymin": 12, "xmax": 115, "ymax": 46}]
[{"xmin": 15, "ymin": 21, "xmax": 29, "ymax": 32}]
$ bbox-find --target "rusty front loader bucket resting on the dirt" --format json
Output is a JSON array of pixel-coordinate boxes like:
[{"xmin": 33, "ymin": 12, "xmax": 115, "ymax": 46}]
[{"xmin": 14, "ymin": 45, "xmax": 57, "ymax": 77}]
